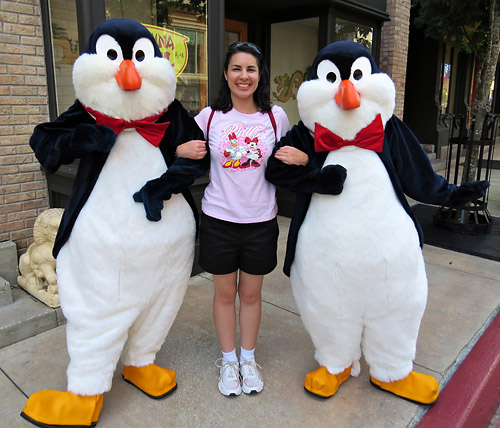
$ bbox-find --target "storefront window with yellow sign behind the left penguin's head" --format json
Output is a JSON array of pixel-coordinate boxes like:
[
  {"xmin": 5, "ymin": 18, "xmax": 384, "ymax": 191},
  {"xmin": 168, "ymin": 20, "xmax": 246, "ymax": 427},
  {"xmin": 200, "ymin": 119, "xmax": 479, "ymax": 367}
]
[{"xmin": 106, "ymin": 0, "xmax": 208, "ymax": 115}]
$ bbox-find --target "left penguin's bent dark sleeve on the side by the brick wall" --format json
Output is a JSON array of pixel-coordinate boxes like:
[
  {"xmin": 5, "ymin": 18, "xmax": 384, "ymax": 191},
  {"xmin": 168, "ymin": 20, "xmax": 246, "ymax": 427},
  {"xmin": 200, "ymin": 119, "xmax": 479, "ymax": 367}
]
[{"xmin": 30, "ymin": 101, "xmax": 116, "ymax": 173}]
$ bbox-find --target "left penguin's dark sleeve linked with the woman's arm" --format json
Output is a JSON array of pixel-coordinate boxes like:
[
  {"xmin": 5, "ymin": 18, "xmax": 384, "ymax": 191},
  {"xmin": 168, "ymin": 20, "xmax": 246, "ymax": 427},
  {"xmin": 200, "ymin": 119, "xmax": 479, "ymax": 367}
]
[{"xmin": 134, "ymin": 100, "xmax": 210, "ymax": 221}]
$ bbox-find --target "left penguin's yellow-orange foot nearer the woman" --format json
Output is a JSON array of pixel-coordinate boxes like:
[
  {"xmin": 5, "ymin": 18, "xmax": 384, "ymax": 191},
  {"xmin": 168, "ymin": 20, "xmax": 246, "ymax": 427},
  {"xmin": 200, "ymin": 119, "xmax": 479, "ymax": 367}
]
[{"xmin": 123, "ymin": 364, "xmax": 177, "ymax": 399}]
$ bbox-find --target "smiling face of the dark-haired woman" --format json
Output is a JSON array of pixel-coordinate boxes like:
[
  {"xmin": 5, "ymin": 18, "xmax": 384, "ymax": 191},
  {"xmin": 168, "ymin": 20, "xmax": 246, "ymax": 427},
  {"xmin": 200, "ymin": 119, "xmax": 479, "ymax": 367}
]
[{"xmin": 224, "ymin": 52, "xmax": 260, "ymax": 100}]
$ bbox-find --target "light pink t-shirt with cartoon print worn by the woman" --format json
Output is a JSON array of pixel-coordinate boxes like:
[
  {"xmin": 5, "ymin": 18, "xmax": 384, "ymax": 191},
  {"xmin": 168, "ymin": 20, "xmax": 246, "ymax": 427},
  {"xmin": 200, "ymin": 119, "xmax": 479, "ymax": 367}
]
[{"xmin": 195, "ymin": 106, "xmax": 290, "ymax": 223}]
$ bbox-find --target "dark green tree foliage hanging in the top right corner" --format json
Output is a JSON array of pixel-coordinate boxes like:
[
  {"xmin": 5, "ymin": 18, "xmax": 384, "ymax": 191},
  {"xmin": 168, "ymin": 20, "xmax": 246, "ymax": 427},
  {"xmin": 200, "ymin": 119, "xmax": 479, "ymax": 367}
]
[{"xmin": 415, "ymin": 0, "xmax": 490, "ymax": 58}]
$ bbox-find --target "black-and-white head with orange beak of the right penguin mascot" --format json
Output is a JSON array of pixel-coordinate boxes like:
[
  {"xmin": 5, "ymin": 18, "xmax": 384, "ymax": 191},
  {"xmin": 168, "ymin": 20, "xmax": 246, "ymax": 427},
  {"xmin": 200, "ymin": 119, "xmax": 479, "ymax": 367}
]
[{"xmin": 297, "ymin": 41, "xmax": 396, "ymax": 140}]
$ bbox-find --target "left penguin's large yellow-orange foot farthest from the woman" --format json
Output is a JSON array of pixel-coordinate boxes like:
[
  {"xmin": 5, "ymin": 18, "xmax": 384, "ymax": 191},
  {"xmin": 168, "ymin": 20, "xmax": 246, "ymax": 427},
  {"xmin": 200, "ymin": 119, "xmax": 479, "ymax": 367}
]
[{"xmin": 21, "ymin": 390, "xmax": 103, "ymax": 428}]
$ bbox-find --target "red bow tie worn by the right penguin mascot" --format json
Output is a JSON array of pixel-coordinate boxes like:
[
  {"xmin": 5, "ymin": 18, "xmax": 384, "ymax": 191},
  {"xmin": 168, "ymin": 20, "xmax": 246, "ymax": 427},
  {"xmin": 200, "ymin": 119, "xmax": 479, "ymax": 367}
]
[{"xmin": 314, "ymin": 114, "xmax": 384, "ymax": 153}]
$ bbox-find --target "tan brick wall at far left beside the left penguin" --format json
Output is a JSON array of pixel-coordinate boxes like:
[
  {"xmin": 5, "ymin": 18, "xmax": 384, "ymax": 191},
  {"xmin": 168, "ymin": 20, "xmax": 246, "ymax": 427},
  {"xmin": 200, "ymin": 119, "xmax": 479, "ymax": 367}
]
[{"xmin": 0, "ymin": 0, "xmax": 49, "ymax": 254}]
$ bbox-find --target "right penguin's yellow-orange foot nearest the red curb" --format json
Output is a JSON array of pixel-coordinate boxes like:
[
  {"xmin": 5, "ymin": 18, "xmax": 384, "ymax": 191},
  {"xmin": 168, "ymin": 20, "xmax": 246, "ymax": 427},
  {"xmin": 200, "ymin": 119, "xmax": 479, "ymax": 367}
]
[{"xmin": 370, "ymin": 371, "xmax": 439, "ymax": 404}]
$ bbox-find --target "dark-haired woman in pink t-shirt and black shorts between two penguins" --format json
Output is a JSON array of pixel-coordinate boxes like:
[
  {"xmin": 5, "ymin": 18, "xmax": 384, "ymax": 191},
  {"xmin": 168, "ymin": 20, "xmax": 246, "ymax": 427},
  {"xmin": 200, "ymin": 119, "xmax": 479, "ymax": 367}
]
[{"xmin": 177, "ymin": 42, "xmax": 307, "ymax": 396}]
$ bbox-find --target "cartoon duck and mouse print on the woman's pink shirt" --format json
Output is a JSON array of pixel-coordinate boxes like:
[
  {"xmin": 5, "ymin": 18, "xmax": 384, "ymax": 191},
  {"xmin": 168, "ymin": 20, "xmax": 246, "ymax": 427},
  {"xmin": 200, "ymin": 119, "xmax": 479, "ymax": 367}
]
[{"xmin": 219, "ymin": 123, "xmax": 267, "ymax": 171}]
